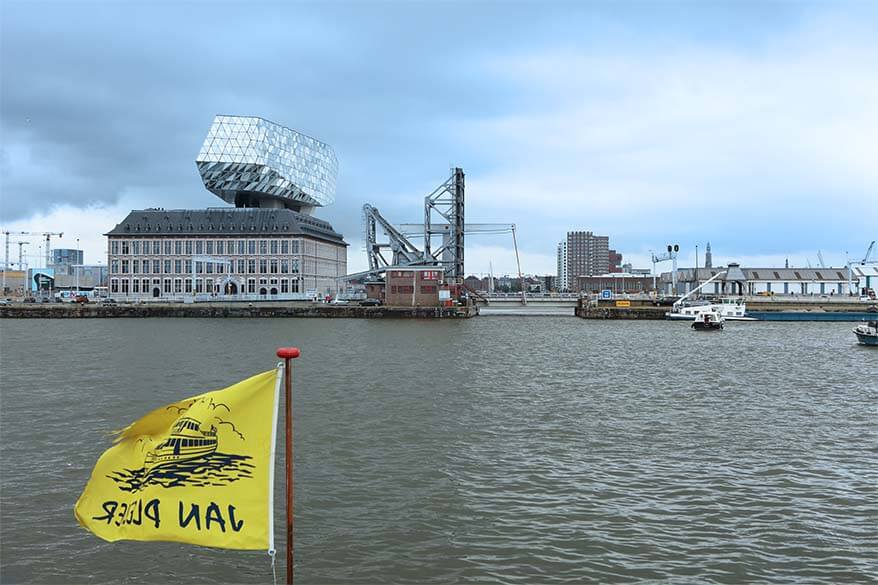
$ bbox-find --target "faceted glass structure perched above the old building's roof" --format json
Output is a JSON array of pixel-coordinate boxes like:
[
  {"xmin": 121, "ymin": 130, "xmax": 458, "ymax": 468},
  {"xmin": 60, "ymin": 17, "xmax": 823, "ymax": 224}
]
[{"xmin": 196, "ymin": 116, "xmax": 338, "ymax": 213}]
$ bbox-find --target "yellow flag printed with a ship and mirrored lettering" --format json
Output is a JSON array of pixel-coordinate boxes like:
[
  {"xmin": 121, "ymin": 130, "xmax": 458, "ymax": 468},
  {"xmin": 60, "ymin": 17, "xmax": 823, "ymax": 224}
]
[{"xmin": 74, "ymin": 369, "xmax": 281, "ymax": 550}]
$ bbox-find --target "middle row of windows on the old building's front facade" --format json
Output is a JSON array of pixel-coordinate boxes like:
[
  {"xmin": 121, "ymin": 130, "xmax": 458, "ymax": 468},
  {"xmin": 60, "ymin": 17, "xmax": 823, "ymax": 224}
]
[{"xmin": 110, "ymin": 258, "xmax": 299, "ymax": 274}]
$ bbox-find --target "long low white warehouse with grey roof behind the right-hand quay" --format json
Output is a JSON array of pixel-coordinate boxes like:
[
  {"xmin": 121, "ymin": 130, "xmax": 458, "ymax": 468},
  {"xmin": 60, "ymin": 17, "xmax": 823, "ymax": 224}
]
[{"xmin": 658, "ymin": 264, "xmax": 858, "ymax": 296}]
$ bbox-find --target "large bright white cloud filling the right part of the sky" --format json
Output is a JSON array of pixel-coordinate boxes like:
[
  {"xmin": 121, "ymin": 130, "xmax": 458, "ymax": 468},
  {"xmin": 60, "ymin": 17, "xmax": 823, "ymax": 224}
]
[{"xmin": 455, "ymin": 22, "xmax": 878, "ymax": 254}]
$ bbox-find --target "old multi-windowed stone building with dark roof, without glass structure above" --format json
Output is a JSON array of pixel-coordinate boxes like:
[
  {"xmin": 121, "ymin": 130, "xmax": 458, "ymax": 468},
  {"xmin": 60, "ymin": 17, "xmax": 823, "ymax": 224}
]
[{"xmin": 105, "ymin": 207, "xmax": 347, "ymax": 301}]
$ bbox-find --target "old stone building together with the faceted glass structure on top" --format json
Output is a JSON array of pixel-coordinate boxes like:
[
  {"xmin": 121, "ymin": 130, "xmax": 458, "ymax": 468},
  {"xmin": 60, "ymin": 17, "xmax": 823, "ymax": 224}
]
[{"xmin": 105, "ymin": 116, "xmax": 347, "ymax": 300}]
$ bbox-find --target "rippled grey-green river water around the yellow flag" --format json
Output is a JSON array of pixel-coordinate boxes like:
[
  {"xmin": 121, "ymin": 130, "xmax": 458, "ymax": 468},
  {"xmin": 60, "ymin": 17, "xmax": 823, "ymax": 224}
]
[{"xmin": 0, "ymin": 316, "xmax": 878, "ymax": 584}]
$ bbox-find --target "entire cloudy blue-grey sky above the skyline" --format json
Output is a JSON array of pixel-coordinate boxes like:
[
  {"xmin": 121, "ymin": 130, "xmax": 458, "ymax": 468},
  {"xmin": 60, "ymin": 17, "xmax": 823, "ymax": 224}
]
[{"xmin": 0, "ymin": 0, "xmax": 878, "ymax": 273}]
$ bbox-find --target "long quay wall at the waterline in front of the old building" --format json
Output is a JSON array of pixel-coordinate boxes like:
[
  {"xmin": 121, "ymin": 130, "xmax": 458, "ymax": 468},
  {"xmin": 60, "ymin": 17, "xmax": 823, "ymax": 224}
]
[{"xmin": 0, "ymin": 303, "xmax": 479, "ymax": 319}]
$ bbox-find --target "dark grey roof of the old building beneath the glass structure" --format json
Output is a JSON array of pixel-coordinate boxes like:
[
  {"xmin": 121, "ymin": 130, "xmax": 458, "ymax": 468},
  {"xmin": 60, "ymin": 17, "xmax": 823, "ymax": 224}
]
[{"xmin": 104, "ymin": 207, "xmax": 347, "ymax": 246}]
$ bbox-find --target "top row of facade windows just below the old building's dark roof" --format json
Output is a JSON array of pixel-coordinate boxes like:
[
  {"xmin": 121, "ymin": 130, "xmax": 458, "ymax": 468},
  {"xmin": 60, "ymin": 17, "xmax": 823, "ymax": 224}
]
[{"xmin": 110, "ymin": 239, "xmax": 299, "ymax": 256}]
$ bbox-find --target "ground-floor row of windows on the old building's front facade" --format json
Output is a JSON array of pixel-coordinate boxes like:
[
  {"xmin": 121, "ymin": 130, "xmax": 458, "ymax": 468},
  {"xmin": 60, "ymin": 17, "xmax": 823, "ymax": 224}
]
[{"xmin": 110, "ymin": 278, "xmax": 299, "ymax": 297}]
